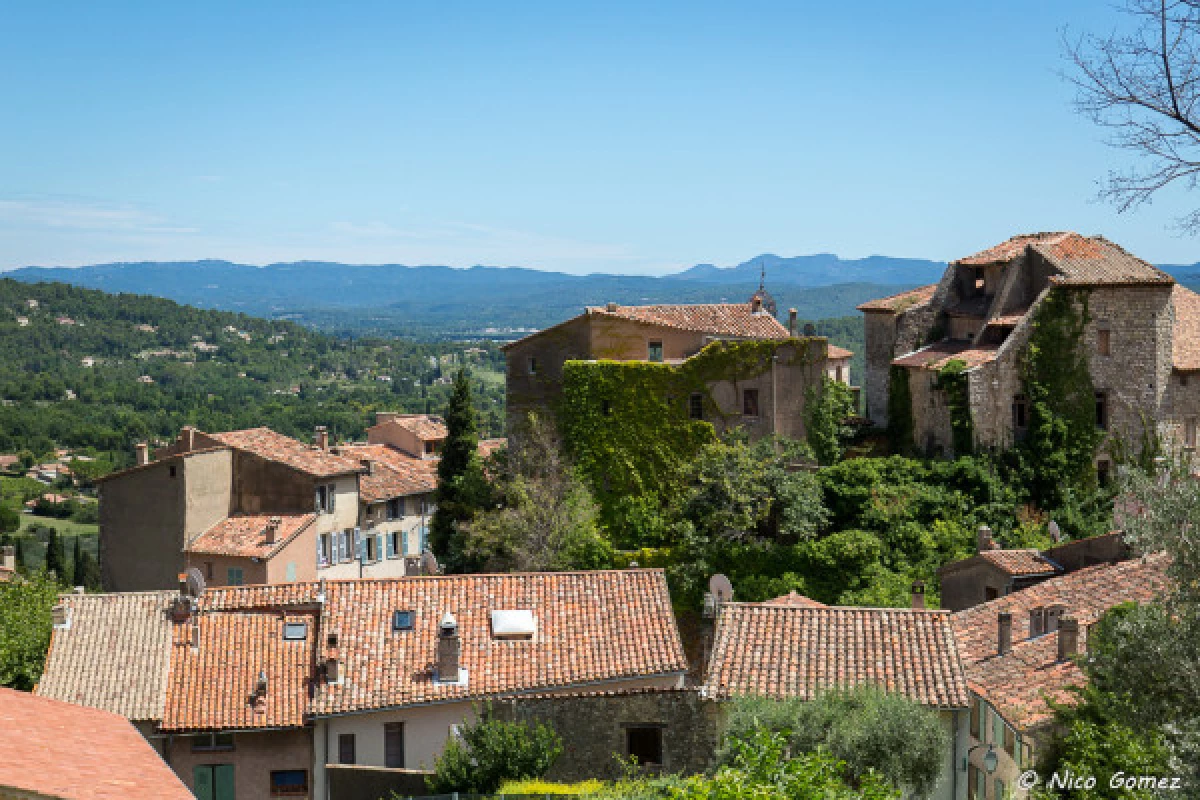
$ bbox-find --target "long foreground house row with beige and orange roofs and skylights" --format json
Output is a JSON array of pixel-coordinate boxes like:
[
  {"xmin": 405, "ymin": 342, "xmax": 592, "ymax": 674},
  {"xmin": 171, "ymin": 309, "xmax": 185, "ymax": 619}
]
[{"xmin": 37, "ymin": 570, "xmax": 691, "ymax": 800}]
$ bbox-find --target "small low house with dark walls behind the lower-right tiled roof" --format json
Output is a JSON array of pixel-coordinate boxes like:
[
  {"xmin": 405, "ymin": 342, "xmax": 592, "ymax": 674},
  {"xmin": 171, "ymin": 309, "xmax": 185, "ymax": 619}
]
[{"xmin": 937, "ymin": 525, "xmax": 1132, "ymax": 612}]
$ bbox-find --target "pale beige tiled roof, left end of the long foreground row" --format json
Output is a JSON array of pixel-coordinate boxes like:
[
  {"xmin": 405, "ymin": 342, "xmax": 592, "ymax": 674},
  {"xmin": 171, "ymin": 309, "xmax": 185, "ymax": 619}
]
[{"xmin": 36, "ymin": 591, "xmax": 178, "ymax": 720}]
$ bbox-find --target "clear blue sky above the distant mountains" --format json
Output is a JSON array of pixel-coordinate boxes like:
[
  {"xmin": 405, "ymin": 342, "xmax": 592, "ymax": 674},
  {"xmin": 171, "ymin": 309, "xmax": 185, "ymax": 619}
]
[{"xmin": 0, "ymin": 0, "xmax": 1200, "ymax": 275}]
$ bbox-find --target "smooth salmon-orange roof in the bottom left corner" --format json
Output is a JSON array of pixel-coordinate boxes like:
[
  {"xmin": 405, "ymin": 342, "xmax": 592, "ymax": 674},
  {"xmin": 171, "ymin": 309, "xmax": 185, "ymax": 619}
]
[{"xmin": 0, "ymin": 688, "xmax": 192, "ymax": 800}]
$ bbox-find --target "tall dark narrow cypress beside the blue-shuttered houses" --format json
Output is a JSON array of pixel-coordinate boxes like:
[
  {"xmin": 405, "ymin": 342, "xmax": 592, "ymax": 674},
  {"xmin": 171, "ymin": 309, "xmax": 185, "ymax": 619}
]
[{"xmin": 430, "ymin": 369, "xmax": 490, "ymax": 572}]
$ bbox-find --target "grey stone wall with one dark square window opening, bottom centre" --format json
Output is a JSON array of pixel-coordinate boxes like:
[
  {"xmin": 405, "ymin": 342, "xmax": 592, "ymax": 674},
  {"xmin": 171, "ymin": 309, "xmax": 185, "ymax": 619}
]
[{"xmin": 496, "ymin": 688, "xmax": 720, "ymax": 781}]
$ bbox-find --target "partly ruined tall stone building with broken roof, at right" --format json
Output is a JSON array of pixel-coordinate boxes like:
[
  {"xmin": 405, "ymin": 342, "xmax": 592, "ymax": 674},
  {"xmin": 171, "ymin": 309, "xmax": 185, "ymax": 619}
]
[{"xmin": 859, "ymin": 233, "xmax": 1200, "ymax": 462}]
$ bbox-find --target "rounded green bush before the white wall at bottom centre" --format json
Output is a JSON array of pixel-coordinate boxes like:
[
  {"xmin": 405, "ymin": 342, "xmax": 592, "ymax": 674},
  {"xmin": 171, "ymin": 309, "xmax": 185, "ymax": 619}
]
[{"xmin": 426, "ymin": 705, "xmax": 563, "ymax": 794}]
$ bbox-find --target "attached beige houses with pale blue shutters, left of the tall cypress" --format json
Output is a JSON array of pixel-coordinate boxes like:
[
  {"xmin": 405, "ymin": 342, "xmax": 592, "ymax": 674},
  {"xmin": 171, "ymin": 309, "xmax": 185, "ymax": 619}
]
[{"xmin": 97, "ymin": 415, "xmax": 445, "ymax": 591}]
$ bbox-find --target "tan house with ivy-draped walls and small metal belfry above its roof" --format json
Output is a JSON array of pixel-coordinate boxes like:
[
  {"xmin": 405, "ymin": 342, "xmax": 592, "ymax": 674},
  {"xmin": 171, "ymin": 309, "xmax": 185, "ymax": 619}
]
[{"xmin": 503, "ymin": 290, "xmax": 853, "ymax": 439}]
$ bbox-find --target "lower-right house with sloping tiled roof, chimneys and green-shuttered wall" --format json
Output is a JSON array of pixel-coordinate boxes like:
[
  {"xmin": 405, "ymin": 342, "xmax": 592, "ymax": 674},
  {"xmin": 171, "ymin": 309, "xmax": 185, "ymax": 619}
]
[{"xmin": 952, "ymin": 553, "xmax": 1166, "ymax": 800}]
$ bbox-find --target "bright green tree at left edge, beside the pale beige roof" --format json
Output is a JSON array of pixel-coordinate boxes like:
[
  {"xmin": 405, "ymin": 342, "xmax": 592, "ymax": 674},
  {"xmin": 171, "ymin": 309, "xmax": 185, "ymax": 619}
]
[{"xmin": 0, "ymin": 571, "xmax": 59, "ymax": 692}]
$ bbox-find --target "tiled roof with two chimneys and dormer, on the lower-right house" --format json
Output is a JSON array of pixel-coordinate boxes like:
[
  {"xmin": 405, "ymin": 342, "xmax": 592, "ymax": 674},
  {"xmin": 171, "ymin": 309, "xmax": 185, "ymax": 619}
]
[{"xmin": 953, "ymin": 554, "xmax": 1166, "ymax": 730}]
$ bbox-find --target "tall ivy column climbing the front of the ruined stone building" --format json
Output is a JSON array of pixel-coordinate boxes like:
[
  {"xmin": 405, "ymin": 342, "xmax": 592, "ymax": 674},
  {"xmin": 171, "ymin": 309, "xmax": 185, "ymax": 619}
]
[{"xmin": 1020, "ymin": 288, "xmax": 1103, "ymax": 509}]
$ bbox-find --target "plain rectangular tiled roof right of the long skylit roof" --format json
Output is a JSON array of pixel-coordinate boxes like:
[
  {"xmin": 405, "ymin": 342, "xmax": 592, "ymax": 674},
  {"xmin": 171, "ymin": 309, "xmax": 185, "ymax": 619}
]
[{"xmin": 704, "ymin": 603, "xmax": 968, "ymax": 708}]
